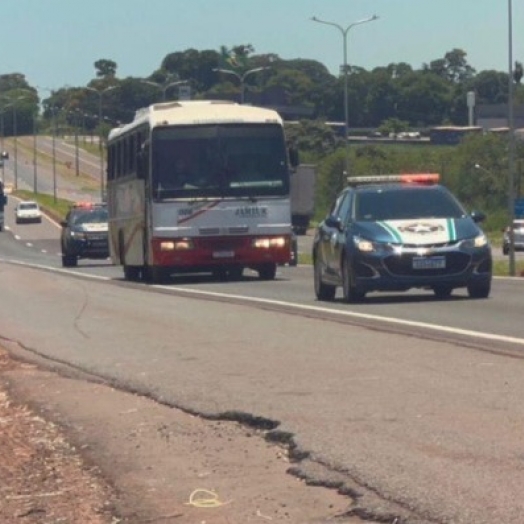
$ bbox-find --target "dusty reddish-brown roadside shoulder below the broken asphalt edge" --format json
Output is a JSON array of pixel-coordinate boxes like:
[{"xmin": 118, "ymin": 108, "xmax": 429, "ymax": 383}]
[{"xmin": 0, "ymin": 349, "xmax": 378, "ymax": 524}]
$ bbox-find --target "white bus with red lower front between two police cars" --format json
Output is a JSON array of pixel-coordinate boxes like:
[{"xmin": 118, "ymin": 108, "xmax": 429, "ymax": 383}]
[{"xmin": 107, "ymin": 101, "xmax": 298, "ymax": 282}]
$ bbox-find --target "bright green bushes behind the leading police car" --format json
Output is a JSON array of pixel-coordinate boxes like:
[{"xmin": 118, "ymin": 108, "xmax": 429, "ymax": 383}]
[{"xmin": 316, "ymin": 134, "xmax": 524, "ymax": 227}]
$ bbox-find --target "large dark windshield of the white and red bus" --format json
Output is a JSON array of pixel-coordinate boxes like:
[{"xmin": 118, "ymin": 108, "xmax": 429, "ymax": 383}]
[{"xmin": 151, "ymin": 123, "xmax": 289, "ymax": 199}]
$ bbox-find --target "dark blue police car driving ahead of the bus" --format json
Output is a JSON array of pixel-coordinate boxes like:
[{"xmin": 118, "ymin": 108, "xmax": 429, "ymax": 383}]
[{"xmin": 312, "ymin": 173, "xmax": 492, "ymax": 302}]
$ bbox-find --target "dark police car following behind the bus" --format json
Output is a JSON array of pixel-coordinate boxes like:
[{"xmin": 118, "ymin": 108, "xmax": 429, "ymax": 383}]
[{"xmin": 60, "ymin": 203, "xmax": 109, "ymax": 267}]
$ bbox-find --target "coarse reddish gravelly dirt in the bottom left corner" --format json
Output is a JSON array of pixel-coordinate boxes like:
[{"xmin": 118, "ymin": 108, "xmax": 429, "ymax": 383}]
[{"xmin": 0, "ymin": 351, "xmax": 114, "ymax": 524}]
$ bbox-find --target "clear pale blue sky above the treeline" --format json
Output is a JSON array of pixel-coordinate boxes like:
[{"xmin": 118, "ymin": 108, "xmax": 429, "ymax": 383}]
[{"xmin": 0, "ymin": 0, "xmax": 524, "ymax": 98}]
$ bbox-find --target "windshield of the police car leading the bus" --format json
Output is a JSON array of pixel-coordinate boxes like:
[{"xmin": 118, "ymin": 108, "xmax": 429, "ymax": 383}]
[{"xmin": 355, "ymin": 187, "xmax": 466, "ymax": 221}]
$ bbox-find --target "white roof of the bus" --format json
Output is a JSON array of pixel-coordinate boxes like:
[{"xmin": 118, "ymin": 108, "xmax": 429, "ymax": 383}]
[{"xmin": 109, "ymin": 100, "xmax": 282, "ymax": 140}]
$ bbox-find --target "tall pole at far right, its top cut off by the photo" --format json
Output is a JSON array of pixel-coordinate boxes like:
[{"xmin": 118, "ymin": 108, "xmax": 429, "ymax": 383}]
[{"xmin": 508, "ymin": 0, "xmax": 515, "ymax": 277}]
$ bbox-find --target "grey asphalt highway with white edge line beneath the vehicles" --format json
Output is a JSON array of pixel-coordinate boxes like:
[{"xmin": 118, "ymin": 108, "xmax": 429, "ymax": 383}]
[{"xmin": 0, "ymin": 137, "xmax": 524, "ymax": 524}]
